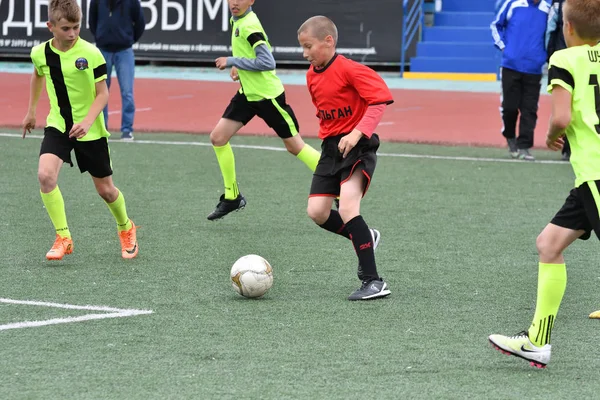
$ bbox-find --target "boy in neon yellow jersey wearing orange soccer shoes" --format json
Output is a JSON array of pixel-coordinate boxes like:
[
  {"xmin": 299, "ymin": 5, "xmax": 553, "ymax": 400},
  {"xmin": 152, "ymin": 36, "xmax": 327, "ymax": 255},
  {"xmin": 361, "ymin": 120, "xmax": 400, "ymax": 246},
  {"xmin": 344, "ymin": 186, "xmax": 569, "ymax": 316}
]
[{"xmin": 23, "ymin": 0, "xmax": 139, "ymax": 260}]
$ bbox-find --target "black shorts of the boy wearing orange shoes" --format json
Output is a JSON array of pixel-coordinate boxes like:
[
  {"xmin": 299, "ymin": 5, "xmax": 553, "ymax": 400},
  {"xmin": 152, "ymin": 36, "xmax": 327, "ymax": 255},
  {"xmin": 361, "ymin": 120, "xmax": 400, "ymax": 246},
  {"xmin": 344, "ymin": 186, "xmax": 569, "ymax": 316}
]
[{"xmin": 40, "ymin": 127, "xmax": 112, "ymax": 178}]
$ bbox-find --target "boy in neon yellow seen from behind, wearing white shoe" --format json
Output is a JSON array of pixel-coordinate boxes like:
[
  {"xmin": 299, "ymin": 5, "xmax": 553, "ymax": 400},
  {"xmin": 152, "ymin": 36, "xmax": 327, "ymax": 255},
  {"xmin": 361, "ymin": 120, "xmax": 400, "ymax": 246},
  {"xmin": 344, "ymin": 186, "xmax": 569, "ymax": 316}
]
[{"xmin": 489, "ymin": 0, "xmax": 600, "ymax": 368}]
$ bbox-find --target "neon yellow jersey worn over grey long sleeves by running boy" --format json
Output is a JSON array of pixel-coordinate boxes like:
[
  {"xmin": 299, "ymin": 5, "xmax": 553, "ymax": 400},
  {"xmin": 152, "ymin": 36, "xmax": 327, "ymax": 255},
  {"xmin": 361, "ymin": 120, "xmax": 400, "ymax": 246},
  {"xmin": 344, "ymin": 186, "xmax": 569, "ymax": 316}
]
[{"xmin": 231, "ymin": 11, "xmax": 284, "ymax": 101}]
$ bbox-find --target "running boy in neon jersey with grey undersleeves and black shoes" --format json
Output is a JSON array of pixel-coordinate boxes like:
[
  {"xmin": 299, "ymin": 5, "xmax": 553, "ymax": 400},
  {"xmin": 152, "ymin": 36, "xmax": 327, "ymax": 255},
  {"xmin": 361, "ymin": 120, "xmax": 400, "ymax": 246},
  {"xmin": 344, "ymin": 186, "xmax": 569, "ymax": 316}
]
[{"xmin": 207, "ymin": 0, "xmax": 321, "ymax": 220}]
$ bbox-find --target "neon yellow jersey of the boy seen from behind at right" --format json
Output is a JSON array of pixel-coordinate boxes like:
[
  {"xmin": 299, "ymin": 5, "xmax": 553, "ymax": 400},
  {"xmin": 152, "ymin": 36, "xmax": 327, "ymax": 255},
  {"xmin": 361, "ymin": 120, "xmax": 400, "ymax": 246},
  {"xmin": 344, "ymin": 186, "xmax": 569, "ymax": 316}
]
[{"xmin": 548, "ymin": 44, "xmax": 600, "ymax": 187}]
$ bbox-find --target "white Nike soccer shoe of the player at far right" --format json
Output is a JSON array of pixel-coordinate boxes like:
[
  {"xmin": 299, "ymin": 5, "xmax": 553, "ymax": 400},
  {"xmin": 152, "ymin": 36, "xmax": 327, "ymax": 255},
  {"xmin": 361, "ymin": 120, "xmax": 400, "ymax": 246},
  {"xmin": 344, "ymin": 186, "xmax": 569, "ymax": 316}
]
[{"xmin": 488, "ymin": 331, "xmax": 552, "ymax": 368}]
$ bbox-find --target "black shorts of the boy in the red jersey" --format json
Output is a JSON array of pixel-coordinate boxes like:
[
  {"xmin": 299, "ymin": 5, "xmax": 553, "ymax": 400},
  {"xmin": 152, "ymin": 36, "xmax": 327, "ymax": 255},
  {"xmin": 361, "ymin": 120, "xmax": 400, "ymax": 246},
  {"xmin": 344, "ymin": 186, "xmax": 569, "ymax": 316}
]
[{"xmin": 310, "ymin": 133, "xmax": 379, "ymax": 197}]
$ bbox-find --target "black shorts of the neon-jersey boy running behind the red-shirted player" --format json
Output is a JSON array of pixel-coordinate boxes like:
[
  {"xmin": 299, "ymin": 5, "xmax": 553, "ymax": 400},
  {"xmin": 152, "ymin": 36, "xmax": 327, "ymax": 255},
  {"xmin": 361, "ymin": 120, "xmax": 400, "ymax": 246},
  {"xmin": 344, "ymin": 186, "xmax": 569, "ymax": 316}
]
[{"xmin": 223, "ymin": 92, "xmax": 300, "ymax": 139}]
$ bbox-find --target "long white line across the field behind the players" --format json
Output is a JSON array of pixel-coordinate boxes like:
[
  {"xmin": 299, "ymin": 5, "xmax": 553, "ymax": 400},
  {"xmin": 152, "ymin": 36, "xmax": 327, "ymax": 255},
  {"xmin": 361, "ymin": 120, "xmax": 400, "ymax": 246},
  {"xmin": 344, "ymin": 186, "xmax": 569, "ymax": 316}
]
[{"xmin": 0, "ymin": 132, "xmax": 568, "ymax": 165}]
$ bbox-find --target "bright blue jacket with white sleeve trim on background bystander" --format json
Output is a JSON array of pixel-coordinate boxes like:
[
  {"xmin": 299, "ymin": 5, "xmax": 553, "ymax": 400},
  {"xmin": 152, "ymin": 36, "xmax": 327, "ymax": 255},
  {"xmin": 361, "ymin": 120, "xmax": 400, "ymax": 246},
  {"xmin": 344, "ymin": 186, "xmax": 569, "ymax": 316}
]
[{"xmin": 491, "ymin": 0, "xmax": 550, "ymax": 74}]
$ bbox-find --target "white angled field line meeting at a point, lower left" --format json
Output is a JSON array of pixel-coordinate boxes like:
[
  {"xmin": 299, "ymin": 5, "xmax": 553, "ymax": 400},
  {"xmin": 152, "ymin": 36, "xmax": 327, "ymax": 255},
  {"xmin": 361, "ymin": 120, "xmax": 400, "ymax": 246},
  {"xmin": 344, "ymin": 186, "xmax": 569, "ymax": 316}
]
[{"xmin": 0, "ymin": 298, "xmax": 153, "ymax": 331}]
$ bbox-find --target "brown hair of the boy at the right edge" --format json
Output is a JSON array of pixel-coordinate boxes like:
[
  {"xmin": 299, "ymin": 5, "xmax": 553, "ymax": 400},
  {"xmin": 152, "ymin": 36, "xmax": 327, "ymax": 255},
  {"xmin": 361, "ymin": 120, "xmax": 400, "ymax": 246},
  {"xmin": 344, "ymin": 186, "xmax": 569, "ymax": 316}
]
[{"xmin": 563, "ymin": 0, "xmax": 600, "ymax": 40}]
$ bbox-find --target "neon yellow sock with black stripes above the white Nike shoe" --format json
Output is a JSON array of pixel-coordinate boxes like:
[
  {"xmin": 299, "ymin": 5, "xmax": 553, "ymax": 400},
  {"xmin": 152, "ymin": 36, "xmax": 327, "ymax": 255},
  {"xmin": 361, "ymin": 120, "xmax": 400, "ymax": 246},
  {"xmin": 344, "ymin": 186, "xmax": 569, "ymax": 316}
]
[{"xmin": 528, "ymin": 263, "xmax": 567, "ymax": 347}]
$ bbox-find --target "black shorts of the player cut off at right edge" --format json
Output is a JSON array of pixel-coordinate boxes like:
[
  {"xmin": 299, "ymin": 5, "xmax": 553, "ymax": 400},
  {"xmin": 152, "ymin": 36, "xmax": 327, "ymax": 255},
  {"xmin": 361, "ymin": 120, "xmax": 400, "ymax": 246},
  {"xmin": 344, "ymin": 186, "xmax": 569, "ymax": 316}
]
[{"xmin": 550, "ymin": 181, "xmax": 600, "ymax": 240}]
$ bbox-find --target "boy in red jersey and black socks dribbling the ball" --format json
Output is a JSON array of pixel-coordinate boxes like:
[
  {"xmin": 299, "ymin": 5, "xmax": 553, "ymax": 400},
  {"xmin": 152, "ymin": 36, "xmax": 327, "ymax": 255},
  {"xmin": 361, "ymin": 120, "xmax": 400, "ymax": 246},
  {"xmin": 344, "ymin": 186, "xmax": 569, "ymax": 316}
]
[{"xmin": 298, "ymin": 16, "xmax": 394, "ymax": 300}]
